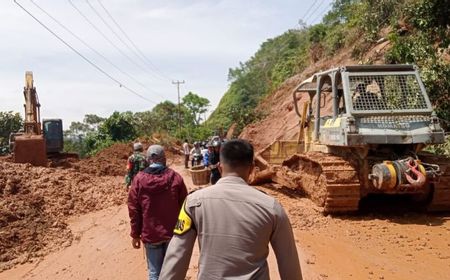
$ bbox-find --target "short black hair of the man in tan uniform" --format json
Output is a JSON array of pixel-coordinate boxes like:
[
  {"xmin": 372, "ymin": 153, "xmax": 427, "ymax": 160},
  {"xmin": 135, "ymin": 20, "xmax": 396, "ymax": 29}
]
[{"xmin": 220, "ymin": 139, "xmax": 254, "ymax": 167}]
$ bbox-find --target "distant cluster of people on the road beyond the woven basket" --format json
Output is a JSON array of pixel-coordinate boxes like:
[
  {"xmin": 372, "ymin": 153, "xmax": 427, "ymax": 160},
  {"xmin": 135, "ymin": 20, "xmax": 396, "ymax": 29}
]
[{"xmin": 183, "ymin": 137, "xmax": 222, "ymax": 185}]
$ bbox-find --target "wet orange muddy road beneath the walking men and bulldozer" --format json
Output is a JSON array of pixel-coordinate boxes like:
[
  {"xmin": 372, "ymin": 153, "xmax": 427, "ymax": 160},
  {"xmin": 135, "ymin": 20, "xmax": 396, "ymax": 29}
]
[{"xmin": 0, "ymin": 164, "xmax": 450, "ymax": 280}]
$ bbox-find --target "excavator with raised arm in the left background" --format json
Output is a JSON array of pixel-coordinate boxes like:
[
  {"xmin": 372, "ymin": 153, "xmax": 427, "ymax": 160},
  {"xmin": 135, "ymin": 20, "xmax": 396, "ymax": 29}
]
[{"xmin": 9, "ymin": 71, "xmax": 69, "ymax": 166}]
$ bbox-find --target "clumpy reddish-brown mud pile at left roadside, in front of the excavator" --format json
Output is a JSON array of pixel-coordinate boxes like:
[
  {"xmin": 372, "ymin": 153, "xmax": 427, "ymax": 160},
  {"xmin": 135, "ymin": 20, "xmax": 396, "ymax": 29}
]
[{"xmin": 0, "ymin": 162, "xmax": 126, "ymax": 271}]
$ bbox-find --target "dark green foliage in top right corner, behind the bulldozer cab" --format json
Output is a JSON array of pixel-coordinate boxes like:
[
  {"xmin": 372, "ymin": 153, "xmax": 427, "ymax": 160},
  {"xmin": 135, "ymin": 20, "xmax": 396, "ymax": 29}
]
[{"xmin": 386, "ymin": 0, "xmax": 450, "ymax": 121}]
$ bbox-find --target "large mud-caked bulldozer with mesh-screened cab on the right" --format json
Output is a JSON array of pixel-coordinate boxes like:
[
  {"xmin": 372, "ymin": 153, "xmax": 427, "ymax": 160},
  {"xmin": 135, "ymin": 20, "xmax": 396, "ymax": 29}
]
[{"xmin": 254, "ymin": 65, "xmax": 450, "ymax": 214}]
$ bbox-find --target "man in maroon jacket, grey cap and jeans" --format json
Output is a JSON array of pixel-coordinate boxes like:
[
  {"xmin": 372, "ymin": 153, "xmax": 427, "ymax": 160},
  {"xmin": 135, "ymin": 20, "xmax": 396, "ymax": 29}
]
[{"xmin": 128, "ymin": 145, "xmax": 187, "ymax": 280}]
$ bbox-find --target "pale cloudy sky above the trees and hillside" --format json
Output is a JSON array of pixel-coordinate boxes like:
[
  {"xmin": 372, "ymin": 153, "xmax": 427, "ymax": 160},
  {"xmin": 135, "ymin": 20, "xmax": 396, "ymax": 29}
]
[{"xmin": 0, "ymin": 0, "xmax": 332, "ymax": 128}]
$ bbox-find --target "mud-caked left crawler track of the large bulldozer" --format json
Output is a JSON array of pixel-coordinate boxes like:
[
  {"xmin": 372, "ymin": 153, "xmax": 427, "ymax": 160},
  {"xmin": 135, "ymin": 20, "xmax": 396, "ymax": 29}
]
[{"xmin": 277, "ymin": 152, "xmax": 361, "ymax": 213}]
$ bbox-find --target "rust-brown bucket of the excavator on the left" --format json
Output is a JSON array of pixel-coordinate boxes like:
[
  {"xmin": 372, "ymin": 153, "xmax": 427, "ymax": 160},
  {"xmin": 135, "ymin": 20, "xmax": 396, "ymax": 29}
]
[{"xmin": 14, "ymin": 135, "xmax": 47, "ymax": 166}]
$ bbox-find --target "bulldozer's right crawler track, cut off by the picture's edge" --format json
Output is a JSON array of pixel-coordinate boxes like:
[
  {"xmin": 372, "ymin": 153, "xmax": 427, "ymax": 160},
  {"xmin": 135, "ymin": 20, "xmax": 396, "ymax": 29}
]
[{"xmin": 419, "ymin": 154, "xmax": 450, "ymax": 212}]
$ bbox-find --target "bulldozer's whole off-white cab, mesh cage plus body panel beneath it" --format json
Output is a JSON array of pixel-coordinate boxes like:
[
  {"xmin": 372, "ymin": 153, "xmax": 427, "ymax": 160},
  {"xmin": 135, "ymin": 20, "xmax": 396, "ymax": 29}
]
[{"xmin": 293, "ymin": 65, "xmax": 444, "ymax": 147}]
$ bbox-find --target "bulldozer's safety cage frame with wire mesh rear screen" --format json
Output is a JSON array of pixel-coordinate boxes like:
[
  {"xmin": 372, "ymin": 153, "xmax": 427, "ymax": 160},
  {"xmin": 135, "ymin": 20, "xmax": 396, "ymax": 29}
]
[{"xmin": 293, "ymin": 65, "xmax": 440, "ymax": 145}]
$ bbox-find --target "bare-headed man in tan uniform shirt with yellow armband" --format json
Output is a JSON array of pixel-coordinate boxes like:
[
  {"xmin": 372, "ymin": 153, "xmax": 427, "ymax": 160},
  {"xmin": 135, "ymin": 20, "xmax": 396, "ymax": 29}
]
[{"xmin": 161, "ymin": 140, "xmax": 302, "ymax": 280}]
